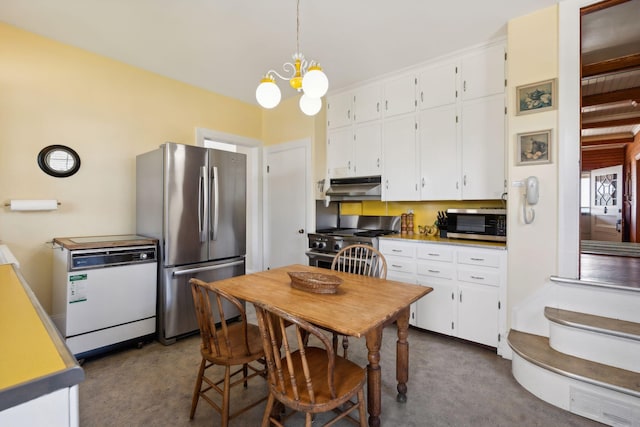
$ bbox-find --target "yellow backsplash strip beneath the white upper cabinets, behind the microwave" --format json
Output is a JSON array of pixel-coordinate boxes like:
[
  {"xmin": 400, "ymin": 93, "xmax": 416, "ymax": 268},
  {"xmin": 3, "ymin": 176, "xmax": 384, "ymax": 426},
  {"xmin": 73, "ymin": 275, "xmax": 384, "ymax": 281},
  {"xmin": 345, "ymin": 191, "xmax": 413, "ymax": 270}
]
[{"xmin": 340, "ymin": 200, "xmax": 506, "ymax": 232}]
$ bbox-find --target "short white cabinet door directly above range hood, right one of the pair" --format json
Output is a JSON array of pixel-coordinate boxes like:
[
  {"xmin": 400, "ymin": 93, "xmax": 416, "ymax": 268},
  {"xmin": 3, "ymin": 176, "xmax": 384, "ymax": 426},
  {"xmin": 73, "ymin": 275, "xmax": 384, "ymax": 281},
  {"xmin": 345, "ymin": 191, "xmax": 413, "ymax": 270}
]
[{"xmin": 353, "ymin": 121, "xmax": 382, "ymax": 176}]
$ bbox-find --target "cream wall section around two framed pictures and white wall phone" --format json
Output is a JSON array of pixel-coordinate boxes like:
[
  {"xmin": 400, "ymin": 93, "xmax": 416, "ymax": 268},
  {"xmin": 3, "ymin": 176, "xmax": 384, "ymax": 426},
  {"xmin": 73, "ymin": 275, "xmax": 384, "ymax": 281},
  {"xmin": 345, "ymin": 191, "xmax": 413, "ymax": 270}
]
[{"xmin": 507, "ymin": 6, "xmax": 556, "ymax": 325}]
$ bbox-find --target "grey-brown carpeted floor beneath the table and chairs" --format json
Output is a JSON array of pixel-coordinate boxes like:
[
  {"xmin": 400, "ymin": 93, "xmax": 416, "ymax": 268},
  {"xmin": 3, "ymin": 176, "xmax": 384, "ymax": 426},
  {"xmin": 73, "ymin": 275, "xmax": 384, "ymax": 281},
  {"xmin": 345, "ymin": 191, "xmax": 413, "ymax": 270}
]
[{"xmin": 80, "ymin": 312, "xmax": 600, "ymax": 427}]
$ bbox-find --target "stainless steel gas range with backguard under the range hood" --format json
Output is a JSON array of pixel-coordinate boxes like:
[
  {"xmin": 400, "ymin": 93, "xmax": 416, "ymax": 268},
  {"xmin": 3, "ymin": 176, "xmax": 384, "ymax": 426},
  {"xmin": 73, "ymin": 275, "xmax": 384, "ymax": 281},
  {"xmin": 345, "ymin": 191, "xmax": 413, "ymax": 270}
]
[{"xmin": 306, "ymin": 215, "xmax": 400, "ymax": 268}]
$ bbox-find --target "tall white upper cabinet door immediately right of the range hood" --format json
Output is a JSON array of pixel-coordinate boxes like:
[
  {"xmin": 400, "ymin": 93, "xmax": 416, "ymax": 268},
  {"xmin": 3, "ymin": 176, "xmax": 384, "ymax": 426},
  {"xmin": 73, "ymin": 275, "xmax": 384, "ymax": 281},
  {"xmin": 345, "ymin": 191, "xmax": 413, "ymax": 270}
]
[{"xmin": 382, "ymin": 114, "xmax": 419, "ymax": 201}]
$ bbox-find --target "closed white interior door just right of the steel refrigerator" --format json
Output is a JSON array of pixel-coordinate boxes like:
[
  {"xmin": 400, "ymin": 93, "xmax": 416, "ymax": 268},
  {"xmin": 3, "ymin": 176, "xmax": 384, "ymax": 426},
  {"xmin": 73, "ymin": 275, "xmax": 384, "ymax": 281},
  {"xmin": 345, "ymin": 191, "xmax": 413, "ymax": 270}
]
[{"xmin": 264, "ymin": 139, "xmax": 312, "ymax": 269}]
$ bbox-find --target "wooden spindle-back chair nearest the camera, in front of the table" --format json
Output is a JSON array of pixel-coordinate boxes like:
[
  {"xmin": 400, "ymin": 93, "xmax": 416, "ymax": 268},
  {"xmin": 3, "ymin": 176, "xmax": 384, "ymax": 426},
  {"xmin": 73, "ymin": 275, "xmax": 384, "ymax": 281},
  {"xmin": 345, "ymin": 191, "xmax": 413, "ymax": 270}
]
[{"xmin": 254, "ymin": 303, "xmax": 367, "ymax": 427}]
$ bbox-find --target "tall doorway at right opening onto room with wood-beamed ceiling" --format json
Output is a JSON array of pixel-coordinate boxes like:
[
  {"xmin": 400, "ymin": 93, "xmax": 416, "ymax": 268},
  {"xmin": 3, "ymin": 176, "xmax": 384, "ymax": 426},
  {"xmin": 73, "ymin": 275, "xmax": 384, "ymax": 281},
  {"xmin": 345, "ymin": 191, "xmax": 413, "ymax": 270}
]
[{"xmin": 579, "ymin": 0, "xmax": 640, "ymax": 284}]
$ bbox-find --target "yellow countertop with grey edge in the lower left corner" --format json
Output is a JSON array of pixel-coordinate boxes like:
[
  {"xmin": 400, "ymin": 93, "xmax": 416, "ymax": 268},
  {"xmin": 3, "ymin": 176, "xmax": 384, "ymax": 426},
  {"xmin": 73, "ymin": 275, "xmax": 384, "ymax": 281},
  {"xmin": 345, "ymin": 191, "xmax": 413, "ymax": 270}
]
[{"xmin": 0, "ymin": 264, "xmax": 84, "ymax": 411}]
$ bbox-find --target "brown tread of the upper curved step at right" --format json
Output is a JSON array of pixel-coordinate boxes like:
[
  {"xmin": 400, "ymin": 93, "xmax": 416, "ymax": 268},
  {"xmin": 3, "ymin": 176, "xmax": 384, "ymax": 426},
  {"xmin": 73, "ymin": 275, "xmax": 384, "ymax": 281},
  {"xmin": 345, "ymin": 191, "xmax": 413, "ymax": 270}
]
[{"xmin": 544, "ymin": 307, "xmax": 640, "ymax": 341}]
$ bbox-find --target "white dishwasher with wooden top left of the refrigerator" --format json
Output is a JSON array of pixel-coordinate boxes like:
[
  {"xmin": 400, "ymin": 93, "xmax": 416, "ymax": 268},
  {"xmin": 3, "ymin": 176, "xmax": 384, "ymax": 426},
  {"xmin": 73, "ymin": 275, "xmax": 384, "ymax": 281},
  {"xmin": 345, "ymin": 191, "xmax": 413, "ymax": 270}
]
[{"xmin": 51, "ymin": 235, "xmax": 158, "ymax": 359}]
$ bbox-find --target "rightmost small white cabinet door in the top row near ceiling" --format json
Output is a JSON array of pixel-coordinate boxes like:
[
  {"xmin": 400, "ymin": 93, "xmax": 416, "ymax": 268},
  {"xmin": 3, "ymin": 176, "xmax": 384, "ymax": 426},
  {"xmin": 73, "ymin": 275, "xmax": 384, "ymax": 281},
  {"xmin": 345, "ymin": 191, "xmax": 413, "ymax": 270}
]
[{"xmin": 461, "ymin": 44, "xmax": 505, "ymax": 101}]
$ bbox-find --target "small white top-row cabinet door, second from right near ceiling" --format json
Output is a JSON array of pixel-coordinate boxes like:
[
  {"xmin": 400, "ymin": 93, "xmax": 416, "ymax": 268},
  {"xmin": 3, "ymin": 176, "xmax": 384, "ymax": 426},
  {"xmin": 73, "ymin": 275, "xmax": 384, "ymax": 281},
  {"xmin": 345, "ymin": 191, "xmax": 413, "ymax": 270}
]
[{"xmin": 418, "ymin": 61, "xmax": 458, "ymax": 109}]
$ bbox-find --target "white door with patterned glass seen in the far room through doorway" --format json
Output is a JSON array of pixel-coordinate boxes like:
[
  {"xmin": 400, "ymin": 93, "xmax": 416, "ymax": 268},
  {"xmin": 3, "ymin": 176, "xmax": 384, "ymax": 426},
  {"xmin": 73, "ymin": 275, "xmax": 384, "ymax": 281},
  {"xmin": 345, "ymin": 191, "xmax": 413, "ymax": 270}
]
[{"xmin": 591, "ymin": 165, "xmax": 623, "ymax": 242}]
